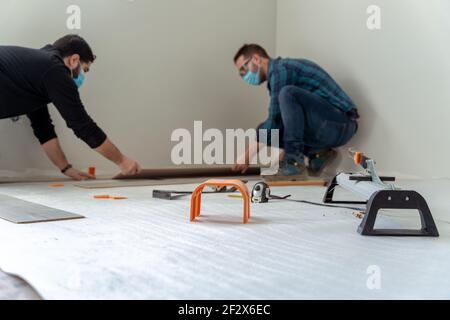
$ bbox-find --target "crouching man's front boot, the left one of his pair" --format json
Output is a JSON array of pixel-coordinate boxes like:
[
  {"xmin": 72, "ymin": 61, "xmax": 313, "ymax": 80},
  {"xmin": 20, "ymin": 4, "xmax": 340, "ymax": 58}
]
[{"xmin": 263, "ymin": 154, "xmax": 308, "ymax": 181}]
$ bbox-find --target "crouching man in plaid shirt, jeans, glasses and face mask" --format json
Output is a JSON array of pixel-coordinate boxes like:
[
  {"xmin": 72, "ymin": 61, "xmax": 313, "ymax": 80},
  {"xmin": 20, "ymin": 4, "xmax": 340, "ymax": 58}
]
[{"xmin": 234, "ymin": 44, "xmax": 359, "ymax": 180}]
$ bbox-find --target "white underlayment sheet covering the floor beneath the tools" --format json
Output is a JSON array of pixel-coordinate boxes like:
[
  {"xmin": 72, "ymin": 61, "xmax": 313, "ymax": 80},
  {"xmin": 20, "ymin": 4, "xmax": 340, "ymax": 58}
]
[{"xmin": 0, "ymin": 180, "xmax": 450, "ymax": 299}]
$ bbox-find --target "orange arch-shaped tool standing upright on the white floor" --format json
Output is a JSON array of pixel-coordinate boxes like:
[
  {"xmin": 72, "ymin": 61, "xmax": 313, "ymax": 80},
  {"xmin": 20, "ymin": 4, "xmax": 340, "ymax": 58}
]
[{"xmin": 190, "ymin": 179, "xmax": 250, "ymax": 224}]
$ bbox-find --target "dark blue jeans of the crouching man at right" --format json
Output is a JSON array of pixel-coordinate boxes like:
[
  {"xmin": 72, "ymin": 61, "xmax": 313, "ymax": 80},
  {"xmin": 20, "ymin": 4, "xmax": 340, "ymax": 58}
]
[{"xmin": 279, "ymin": 86, "xmax": 358, "ymax": 156}]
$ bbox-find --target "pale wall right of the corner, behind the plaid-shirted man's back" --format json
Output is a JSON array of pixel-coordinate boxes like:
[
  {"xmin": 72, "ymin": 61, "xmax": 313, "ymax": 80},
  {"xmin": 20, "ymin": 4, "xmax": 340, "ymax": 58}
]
[{"xmin": 277, "ymin": 0, "xmax": 450, "ymax": 178}]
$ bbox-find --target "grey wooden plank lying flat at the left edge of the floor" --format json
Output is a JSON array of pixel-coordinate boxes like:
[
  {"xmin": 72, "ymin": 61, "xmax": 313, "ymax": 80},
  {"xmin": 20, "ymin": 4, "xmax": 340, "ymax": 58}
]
[{"xmin": 0, "ymin": 195, "xmax": 84, "ymax": 224}]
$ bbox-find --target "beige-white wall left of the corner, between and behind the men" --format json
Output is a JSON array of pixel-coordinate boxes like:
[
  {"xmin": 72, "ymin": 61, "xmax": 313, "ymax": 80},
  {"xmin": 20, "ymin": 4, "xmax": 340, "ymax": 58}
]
[{"xmin": 0, "ymin": 0, "xmax": 276, "ymax": 176}]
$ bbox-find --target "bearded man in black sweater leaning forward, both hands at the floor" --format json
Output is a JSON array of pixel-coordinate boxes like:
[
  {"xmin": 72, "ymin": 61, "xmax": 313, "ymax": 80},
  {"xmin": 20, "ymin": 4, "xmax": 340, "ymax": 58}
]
[{"xmin": 0, "ymin": 35, "xmax": 141, "ymax": 180}]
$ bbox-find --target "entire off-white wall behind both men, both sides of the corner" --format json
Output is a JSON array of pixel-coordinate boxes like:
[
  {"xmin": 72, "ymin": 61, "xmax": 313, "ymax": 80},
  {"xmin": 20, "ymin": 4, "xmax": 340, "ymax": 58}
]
[{"xmin": 0, "ymin": 0, "xmax": 450, "ymax": 177}]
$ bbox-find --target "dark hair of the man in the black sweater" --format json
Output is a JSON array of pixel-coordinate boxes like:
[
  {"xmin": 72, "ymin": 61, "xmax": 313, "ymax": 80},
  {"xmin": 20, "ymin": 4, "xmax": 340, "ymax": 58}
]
[{"xmin": 53, "ymin": 34, "xmax": 97, "ymax": 63}]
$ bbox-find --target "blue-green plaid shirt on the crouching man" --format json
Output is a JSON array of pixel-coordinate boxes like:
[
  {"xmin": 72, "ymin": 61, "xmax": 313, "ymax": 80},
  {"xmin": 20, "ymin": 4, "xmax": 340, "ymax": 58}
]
[{"xmin": 260, "ymin": 58, "xmax": 356, "ymax": 136}]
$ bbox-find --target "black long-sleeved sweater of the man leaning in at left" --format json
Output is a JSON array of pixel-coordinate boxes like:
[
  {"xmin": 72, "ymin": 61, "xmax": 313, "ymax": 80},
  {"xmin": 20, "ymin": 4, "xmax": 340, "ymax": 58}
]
[{"xmin": 0, "ymin": 45, "xmax": 106, "ymax": 148}]
